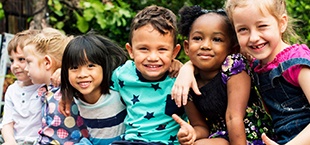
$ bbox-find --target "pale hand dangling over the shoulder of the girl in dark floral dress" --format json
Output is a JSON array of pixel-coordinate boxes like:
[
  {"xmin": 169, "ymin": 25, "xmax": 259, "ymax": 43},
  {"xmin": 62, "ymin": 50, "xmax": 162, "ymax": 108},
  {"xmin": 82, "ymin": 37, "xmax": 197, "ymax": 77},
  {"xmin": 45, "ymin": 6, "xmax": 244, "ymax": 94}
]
[{"xmin": 171, "ymin": 61, "xmax": 201, "ymax": 107}]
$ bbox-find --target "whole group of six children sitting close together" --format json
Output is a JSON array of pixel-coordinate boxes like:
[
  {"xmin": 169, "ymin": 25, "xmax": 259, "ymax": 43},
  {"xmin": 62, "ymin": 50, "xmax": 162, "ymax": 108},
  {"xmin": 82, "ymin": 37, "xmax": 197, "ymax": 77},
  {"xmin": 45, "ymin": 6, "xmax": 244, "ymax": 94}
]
[{"xmin": 2, "ymin": 0, "xmax": 310, "ymax": 145}]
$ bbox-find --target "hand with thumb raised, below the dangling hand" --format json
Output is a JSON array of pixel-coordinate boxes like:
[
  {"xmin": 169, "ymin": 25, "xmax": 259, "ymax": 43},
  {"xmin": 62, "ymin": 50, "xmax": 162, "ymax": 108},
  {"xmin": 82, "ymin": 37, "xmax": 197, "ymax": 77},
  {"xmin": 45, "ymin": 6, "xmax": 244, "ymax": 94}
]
[{"xmin": 172, "ymin": 114, "xmax": 196, "ymax": 145}]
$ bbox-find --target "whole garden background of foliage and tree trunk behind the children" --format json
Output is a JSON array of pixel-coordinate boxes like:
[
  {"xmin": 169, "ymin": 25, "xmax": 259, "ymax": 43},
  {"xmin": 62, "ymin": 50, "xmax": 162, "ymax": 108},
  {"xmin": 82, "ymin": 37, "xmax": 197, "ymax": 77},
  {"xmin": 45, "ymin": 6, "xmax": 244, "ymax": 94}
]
[{"xmin": 0, "ymin": 0, "xmax": 310, "ymax": 101}]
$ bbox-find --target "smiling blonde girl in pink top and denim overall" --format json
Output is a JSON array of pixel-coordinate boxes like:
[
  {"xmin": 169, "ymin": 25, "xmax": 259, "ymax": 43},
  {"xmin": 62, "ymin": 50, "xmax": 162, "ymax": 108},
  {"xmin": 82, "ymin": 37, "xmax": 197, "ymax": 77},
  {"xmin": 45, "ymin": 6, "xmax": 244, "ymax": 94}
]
[{"xmin": 226, "ymin": 0, "xmax": 310, "ymax": 144}]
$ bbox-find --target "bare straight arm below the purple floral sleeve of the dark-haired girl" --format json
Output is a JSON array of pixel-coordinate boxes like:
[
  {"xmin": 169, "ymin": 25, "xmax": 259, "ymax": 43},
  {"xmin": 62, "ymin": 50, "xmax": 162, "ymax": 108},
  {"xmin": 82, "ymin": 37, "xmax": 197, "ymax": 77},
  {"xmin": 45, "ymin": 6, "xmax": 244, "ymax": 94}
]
[{"xmin": 226, "ymin": 71, "xmax": 251, "ymax": 145}]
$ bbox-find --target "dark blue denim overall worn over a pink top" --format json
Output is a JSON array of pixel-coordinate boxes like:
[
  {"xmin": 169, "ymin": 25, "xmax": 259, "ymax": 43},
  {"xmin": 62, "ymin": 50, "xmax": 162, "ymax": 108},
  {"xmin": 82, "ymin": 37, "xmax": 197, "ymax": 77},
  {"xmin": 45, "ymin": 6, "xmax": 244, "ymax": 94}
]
[{"xmin": 254, "ymin": 58, "xmax": 310, "ymax": 144}]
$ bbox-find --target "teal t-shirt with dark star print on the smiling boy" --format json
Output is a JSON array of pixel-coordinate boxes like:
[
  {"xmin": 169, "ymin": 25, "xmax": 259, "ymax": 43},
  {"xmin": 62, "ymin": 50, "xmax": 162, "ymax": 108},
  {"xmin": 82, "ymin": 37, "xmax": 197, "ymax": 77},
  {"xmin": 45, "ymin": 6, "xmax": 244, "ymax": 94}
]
[{"xmin": 111, "ymin": 60, "xmax": 187, "ymax": 144}]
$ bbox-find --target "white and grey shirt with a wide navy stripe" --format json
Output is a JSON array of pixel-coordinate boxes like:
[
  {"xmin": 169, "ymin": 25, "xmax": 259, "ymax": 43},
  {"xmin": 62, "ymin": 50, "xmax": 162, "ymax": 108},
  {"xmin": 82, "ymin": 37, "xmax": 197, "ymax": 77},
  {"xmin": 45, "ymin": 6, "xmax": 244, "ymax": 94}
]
[{"xmin": 75, "ymin": 90, "xmax": 127, "ymax": 145}]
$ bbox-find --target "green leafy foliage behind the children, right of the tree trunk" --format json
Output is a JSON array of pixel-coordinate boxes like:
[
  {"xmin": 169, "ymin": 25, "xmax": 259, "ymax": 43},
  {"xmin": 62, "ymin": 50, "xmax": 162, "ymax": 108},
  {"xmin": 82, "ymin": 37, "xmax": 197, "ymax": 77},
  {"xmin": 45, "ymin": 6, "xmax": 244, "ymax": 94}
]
[{"xmin": 45, "ymin": 0, "xmax": 310, "ymax": 62}]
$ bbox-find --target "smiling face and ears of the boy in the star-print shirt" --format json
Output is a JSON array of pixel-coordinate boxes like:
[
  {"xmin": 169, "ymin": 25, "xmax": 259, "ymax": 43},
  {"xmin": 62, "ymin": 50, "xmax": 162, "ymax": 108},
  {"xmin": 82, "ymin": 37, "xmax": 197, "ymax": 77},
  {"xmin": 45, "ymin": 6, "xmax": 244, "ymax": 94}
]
[{"xmin": 126, "ymin": 24, "xmax": 180, "ymax": 80}]
